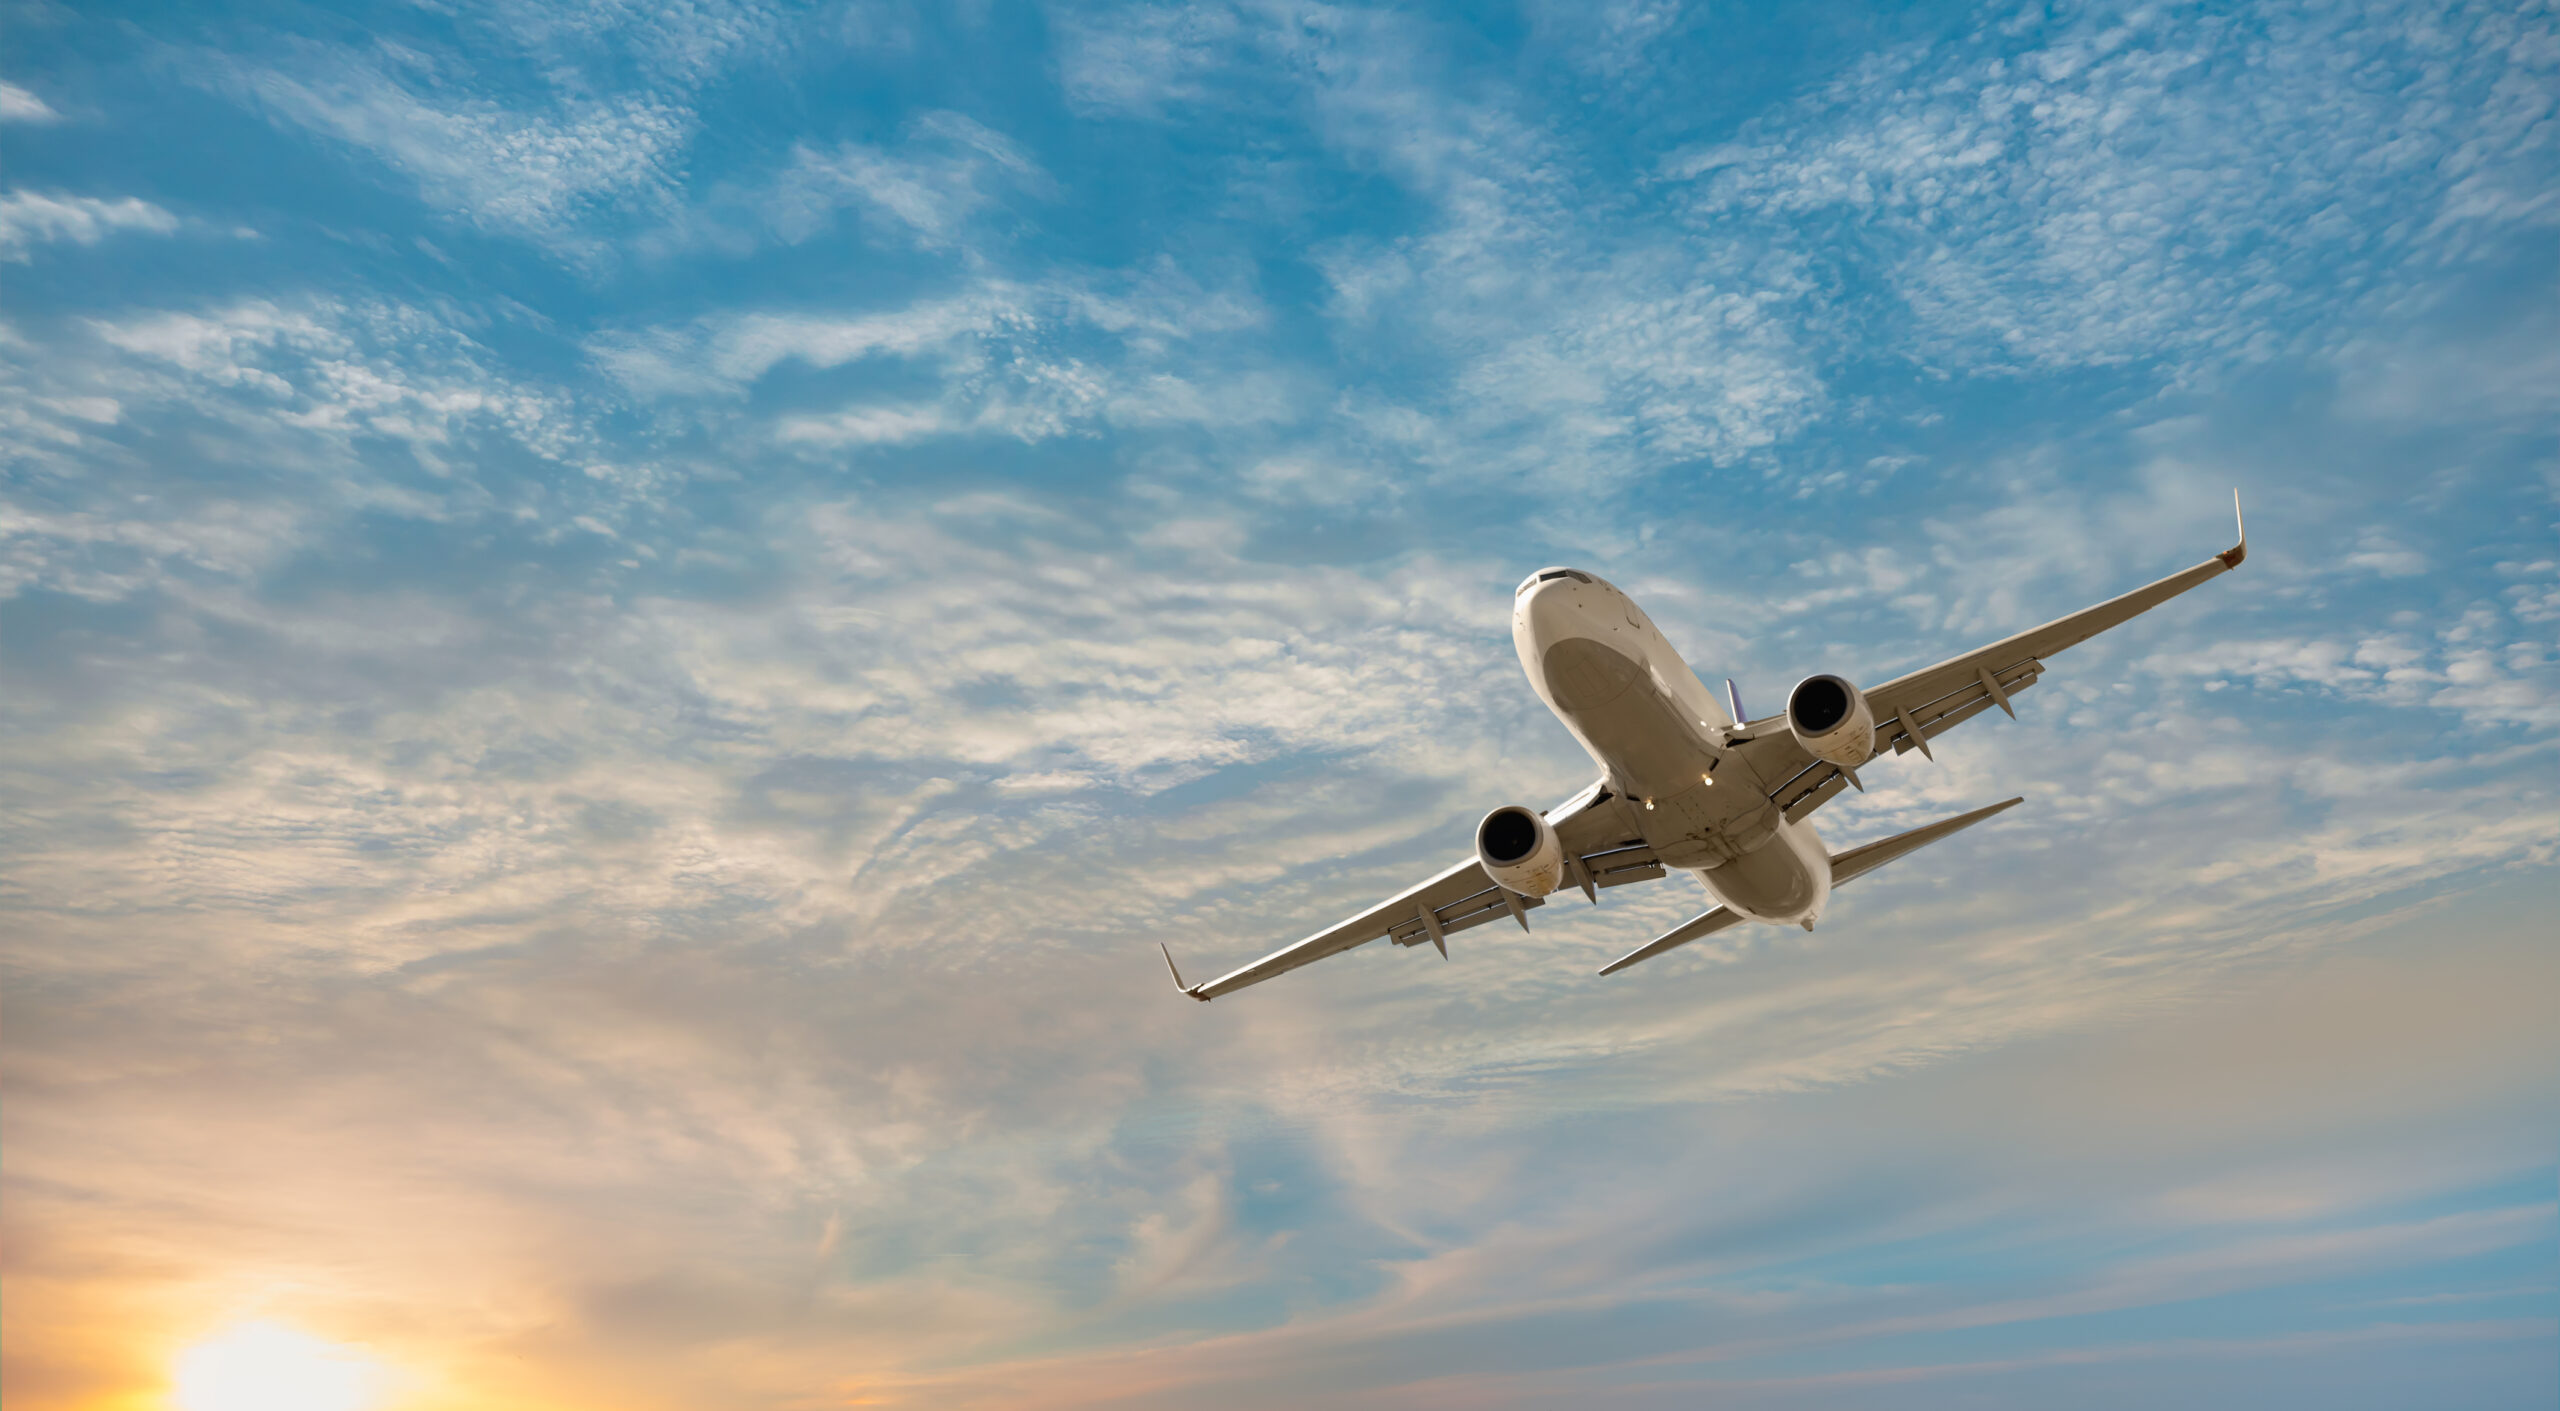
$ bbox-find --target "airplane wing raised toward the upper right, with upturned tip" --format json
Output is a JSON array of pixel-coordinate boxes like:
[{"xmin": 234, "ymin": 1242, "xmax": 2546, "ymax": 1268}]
[{"xmin": 1738, "ymin": 494, "xmax": 2248, "ymax": 819}]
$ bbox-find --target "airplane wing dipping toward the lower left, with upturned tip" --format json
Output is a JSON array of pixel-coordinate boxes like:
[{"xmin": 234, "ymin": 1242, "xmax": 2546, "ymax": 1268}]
[{"xmin": 1165, "ymin": 781, "xmax": 1661, "ymax": 1001}]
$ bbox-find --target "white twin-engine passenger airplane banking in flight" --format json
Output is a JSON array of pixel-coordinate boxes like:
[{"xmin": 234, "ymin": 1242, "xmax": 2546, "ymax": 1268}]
[{"xmin": 1157, "ymin": 492, "xmax": 2248, "ymax": 1001}]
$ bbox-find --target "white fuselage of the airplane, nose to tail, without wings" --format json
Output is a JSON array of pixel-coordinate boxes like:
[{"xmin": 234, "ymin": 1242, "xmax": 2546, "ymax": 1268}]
[{"xmin": 1510, "ymin": 568, "xmax": 1830, "ymax": 930}]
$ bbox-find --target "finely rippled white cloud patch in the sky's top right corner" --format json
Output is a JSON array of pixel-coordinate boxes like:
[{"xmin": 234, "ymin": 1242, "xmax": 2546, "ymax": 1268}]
[{"xmin": 1667, "ymin": 5, "xmax": 2552, "ymax": 366}]
